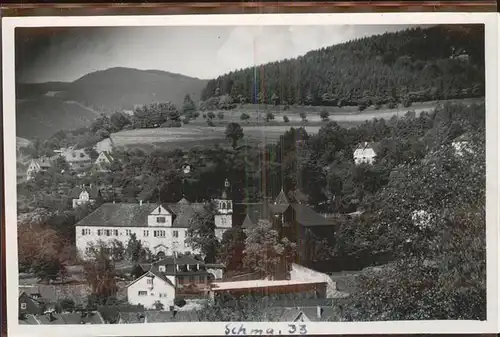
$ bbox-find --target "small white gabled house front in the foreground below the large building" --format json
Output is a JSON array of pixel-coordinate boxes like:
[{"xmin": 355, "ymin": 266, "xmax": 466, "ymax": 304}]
[{"xmin": 127, "ymin": 272, "xmax": 175, "ymax": 310}]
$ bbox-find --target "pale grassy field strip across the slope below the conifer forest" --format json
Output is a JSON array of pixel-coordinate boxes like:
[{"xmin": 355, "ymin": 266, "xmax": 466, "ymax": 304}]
[{"xmin": 104, "ymin": 99, "xmax": 484, "ymax": 150}]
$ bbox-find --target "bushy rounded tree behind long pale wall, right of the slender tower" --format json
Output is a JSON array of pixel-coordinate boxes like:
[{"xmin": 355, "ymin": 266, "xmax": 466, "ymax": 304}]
[{"xmin": 243, "ymin": 220, "xmax": 296, "ymax": 279}]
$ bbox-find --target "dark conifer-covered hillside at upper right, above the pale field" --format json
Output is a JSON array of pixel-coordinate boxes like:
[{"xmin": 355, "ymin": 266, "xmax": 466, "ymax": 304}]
[{"xmin": 202, "ymin": 25, "xmax": 485, "ymax": 106}]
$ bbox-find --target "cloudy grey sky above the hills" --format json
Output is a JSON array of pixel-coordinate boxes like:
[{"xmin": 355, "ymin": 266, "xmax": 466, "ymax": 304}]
[{"xmin": 16, "ymin": 25, "xmax": 420, "ymax": 83}]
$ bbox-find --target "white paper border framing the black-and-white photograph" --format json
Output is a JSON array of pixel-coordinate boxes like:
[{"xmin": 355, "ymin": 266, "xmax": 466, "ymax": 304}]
[{"xmin": 2, "ymin": 13, "xmax": 499, "ymax": 337}]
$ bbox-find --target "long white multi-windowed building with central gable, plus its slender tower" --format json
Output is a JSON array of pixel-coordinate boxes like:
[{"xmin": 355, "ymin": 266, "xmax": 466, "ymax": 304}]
[{"xmin": 76, "ymin": 180, "xmax": 233, "ymax": 258}]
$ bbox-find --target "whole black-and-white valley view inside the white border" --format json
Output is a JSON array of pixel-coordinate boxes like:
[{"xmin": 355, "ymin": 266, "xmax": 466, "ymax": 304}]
[{"xmin": 2, "ymin": 11, "xmax": 496, "ymax": 334}]
